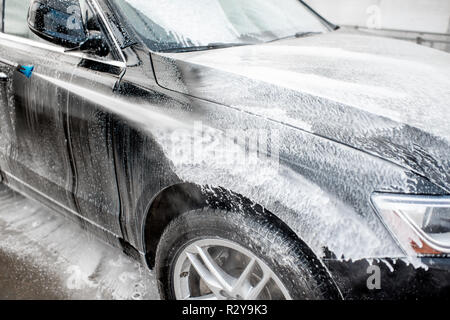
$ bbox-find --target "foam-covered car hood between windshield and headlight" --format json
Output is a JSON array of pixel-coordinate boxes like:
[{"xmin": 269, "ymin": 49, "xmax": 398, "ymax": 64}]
[{"xmin": 153, "ymin": 31, "xmax": 450, "ymax": 192}]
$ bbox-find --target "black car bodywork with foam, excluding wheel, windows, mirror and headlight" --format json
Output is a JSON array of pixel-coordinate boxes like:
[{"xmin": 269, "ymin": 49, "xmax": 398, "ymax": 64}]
[{"xmin": 0, "ymin": 0, "xmax": 450, "ymax": 298}]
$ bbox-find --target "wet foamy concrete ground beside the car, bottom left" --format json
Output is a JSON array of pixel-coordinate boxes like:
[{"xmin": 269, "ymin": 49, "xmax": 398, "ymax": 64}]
[{"xmin": 0, "ymin": 185, "xmax": 159, "ymax": 300}]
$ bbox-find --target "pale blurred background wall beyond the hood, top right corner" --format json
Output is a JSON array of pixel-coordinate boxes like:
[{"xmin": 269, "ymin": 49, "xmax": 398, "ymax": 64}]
[{"xmin": 306, "ymin": 0, "xmax": 450, "ymax": 52}]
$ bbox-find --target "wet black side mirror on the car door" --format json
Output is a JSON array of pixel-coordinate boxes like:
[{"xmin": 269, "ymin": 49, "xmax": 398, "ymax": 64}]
[{"xmin": 28, "ymin": 0, "xmax": 109, "ymax": 56}]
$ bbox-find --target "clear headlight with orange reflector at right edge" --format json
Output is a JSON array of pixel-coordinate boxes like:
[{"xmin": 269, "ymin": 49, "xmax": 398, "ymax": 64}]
[{"xmin": 372, "ymin": 193, "xmax": 450, "ymax": 255}]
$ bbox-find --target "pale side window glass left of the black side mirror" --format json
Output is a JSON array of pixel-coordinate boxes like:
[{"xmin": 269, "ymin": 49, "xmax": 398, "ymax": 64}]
[{"xmin": 3, "ymin": 0, "xmax": 46, "ymax": 42}]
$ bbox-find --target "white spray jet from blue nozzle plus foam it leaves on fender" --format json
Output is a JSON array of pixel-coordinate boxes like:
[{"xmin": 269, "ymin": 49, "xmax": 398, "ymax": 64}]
[{"xmin": 32, "ymin": 63, "xmax": 426, "ymax": 266}]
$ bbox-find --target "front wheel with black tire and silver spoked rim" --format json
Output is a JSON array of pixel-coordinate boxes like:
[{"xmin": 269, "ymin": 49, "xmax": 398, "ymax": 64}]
[{"xmin": 155, "ymin": 209, "xmax": 339, "ymax": 300}]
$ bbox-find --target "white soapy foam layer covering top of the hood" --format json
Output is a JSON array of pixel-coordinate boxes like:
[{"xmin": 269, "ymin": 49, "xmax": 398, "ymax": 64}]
[{"xmin": 174, "ymin": 33, "xmax": 450, "ymax": 141}]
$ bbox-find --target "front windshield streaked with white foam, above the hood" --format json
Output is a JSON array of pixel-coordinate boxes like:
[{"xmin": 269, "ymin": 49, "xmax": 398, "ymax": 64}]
[{"xmin": 114, "ymin": 0, "xmax": 329, "ymax": 51}]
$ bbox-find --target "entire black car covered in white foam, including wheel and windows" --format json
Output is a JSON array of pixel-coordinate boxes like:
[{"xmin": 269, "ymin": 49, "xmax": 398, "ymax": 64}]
[{"xmin": 0, "ymin": 0, "xmax": 450, "ymax": 300}]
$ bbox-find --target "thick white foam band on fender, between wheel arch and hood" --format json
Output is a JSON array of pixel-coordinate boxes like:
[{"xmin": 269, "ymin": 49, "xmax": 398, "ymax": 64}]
[{"xmin": 153, "ymin": 121, "xmax": 407, "ymax": 260}]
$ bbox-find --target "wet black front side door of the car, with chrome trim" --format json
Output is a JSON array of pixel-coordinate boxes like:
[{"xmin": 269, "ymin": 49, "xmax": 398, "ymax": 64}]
[{"xmin": 0, "ymin": 0, "xmax": 125, "ymax": 237}]
